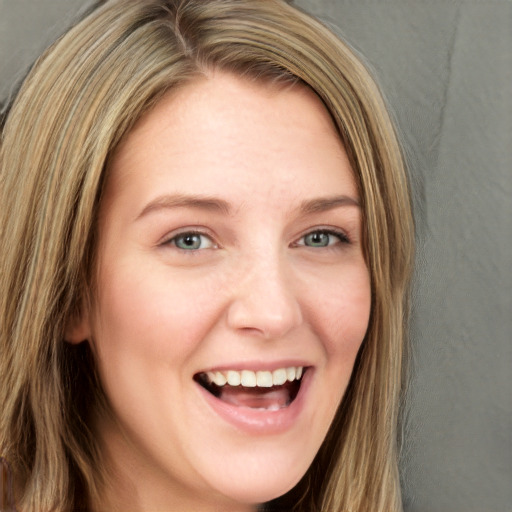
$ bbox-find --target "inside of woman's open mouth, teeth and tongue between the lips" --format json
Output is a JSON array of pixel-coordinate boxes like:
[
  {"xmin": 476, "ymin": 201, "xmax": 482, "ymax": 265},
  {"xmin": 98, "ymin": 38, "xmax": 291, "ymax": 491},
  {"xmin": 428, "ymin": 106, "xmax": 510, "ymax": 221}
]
[{"xmin": 194, "ymin": 366, "xmax": 308, "ymax": 411}]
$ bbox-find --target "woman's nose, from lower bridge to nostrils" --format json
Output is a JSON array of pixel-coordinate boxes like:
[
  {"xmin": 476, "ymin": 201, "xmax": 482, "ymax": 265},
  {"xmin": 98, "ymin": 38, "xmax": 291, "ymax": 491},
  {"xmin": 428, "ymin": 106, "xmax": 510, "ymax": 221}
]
[{"xmin": 227, "ymin": 261, "xmax": 302, "ymax": 339}]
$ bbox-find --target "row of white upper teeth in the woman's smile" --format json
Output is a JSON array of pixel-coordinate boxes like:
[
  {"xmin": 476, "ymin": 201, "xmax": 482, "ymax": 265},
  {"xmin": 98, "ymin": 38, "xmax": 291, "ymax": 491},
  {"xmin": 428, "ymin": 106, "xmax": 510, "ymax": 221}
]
[{"xmin": 206, "ymin": 366, "xmax": 304, "ymax": 388}]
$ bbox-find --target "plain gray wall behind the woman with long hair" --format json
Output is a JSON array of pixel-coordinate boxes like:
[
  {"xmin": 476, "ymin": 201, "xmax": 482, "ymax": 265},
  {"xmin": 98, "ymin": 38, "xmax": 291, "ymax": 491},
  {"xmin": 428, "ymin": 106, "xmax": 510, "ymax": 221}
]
[{"xmin": 0, "ymin": 0, "xmax": 512, "ymax": 512}]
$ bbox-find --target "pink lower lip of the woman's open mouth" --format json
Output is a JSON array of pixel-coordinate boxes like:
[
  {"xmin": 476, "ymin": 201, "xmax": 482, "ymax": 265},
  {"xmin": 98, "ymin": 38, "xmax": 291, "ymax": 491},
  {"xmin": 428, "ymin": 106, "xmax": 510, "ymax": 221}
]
[{"xmin": 197, "ymin": 368, "xmax": 313, "ymax": 435}]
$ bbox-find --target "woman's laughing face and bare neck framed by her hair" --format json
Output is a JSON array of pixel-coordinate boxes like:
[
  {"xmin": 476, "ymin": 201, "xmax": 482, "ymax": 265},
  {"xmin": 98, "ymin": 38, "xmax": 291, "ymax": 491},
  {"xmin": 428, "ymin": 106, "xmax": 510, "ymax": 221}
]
[{"xmin": 82, "ymin": 73, "xmax": 370, "ymax": 511}]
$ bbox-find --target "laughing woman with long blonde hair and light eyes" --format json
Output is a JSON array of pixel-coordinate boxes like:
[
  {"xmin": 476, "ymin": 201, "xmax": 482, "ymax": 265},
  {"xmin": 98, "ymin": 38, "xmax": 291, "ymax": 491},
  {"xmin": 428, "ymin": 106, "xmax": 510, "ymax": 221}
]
[{"xmin": 0, "ymin": 0, "xmax": 412, "ymax": 512}]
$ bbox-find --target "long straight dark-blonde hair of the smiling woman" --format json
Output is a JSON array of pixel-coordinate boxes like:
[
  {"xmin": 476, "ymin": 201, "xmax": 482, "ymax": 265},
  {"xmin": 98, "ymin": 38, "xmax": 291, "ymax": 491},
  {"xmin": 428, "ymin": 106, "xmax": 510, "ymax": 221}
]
[{"xmin": 0, "ymin": 0, "xmax": 413, "ymax": 512}]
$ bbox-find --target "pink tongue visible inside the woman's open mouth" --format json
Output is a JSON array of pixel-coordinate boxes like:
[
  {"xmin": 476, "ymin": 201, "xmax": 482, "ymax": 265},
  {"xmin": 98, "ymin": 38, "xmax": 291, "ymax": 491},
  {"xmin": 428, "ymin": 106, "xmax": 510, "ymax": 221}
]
[{"xmin": 219, "ymin": 385, "xmax": 290, "ymax": 410}]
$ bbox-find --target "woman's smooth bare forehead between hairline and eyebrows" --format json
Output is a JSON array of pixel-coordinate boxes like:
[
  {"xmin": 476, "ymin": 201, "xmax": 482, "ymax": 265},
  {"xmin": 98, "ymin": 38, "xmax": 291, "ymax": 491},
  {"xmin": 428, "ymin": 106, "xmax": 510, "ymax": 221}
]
[{"xmin": 107, "ymin": 73, "xmax": 357, "ymax": 211}]
